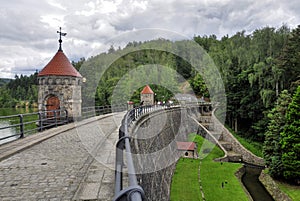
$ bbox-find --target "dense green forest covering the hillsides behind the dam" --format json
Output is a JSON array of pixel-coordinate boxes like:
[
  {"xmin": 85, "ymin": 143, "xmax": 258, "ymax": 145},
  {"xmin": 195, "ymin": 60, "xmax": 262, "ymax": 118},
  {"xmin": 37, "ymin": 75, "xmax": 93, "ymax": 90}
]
[{"xmin": 0, "ymin": 26, "xmax": 300, "ymax": 182}]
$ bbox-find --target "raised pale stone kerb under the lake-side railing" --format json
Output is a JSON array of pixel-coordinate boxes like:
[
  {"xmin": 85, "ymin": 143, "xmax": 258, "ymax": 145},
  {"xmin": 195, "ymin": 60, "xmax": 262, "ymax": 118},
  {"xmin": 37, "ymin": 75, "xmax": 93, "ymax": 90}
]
[{"xmin": 0, "ymin": 113, "xmax": 114, "ymax": 162}]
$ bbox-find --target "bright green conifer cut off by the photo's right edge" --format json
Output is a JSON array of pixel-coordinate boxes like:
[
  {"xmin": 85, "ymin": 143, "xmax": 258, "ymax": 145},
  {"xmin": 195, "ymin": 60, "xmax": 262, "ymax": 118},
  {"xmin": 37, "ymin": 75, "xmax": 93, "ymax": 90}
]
[{"xmin": 280, "ymin": 86, "xmax": 300, "ymax": 183}]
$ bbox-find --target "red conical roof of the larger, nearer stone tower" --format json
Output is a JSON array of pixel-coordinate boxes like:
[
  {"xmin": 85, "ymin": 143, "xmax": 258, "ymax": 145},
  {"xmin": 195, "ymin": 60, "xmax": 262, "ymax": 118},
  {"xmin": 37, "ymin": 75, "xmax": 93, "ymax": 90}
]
[{"xmin": 38, "ymin": 50, "xmax": 82, "ymax": 77}]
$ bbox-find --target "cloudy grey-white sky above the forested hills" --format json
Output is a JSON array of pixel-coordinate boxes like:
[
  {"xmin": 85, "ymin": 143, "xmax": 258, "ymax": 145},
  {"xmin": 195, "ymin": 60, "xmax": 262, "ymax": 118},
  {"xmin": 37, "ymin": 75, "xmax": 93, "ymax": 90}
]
[{"xmin": 0, "ymin": 0, "xmax": 300, "ymax": 78}]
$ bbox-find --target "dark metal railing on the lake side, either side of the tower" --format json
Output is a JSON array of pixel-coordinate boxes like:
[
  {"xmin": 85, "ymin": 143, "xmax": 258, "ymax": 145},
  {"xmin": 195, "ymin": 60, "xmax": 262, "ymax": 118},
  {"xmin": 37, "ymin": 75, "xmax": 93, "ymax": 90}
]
[{"xmin": 0, "ymin": 104, "xmax": 127, "ymax": 144}]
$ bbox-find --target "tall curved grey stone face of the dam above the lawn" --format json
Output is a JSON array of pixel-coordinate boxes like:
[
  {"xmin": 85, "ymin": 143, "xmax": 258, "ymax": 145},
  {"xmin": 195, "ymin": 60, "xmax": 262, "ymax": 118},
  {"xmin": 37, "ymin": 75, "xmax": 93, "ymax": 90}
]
[{"xmin": 131, "ymin": 107, "xmax": 198, "ymax": 201}]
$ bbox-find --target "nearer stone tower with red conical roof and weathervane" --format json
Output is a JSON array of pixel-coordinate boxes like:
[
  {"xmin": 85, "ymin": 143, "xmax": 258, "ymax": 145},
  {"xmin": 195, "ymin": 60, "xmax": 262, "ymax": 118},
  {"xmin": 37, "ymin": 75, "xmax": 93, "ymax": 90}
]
[{"xmin": 38, "ymin": 27, "xmax": 82, "ymax": 120}]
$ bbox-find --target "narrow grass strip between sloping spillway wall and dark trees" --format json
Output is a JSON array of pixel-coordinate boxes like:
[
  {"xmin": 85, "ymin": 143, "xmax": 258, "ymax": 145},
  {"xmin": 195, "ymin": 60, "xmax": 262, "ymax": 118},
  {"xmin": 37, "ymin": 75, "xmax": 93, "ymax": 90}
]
[{"xmin": 226, "ymin": 126, "xmax": 263, "ymax": 157}]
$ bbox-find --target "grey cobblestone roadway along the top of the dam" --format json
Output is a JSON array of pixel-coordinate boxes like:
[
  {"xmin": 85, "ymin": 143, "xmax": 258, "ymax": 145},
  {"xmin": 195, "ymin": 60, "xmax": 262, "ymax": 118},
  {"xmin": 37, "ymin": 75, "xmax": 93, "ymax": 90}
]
[{"xmin": 0, "ymin": 113, "xmax": 125, "ymax": 201}]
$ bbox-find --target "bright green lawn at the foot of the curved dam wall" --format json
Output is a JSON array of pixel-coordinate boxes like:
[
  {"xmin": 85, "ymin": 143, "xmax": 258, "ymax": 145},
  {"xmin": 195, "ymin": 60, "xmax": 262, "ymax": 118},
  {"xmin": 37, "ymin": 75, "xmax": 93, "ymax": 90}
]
[{"xmin": 171, "ymin": 135, "xmax": 248, "ymax": 201}]
